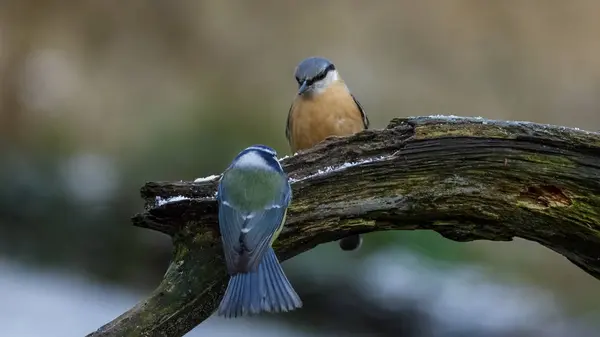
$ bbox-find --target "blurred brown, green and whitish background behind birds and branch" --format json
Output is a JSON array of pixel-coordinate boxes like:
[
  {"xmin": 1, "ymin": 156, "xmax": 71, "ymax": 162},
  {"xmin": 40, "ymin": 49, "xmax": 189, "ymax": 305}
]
[{"xmin": 0, "ymin": 0, "xmax": 600, "ymax": 337}]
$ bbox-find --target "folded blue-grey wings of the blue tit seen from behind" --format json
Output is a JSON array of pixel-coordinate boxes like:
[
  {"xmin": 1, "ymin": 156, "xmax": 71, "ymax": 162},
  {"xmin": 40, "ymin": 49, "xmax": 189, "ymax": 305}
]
[{"xmin": 219, "ymin": 186, "xmax": 287, "ymax": 274}]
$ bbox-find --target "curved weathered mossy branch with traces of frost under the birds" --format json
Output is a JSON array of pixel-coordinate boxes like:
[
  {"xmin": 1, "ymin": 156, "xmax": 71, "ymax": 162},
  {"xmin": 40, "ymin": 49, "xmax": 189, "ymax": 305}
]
[{"xmin": 90, "ymin": 116, "xmax": 600, "ymax": 336}]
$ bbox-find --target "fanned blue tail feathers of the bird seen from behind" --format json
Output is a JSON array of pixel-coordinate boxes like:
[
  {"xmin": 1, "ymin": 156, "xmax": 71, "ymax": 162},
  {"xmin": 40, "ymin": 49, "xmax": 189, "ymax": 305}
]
[{"xmin": 218, "ymin": 247, "xmax": 302, "ymax": 318}]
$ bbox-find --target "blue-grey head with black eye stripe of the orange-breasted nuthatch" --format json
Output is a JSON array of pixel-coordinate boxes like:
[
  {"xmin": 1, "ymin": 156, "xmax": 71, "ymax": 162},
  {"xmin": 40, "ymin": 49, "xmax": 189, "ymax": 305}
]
[{"xmin": 295, "ymin": 56, "xmax": 339, "ymax": 95}]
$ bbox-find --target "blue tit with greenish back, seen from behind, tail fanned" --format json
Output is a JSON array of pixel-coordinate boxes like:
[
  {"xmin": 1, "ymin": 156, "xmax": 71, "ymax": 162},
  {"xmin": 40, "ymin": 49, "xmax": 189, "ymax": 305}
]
[{"xmin": 217, "ymin": 145, "xmax": 302, "ymax": 318}]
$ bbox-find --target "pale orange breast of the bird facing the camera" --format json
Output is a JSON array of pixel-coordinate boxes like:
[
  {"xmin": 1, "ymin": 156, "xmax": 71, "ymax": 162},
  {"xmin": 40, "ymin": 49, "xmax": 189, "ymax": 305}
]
[{"xmin": 289, "ymin": 83, "xmax": 365, "ymax": 153}]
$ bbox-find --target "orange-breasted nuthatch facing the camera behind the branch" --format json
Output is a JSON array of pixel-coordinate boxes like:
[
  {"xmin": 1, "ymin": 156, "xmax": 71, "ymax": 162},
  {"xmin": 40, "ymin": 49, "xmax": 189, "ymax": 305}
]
[{"xmin": 285, "ymin": 57, "xmax": 369, "ymax": 250}]
